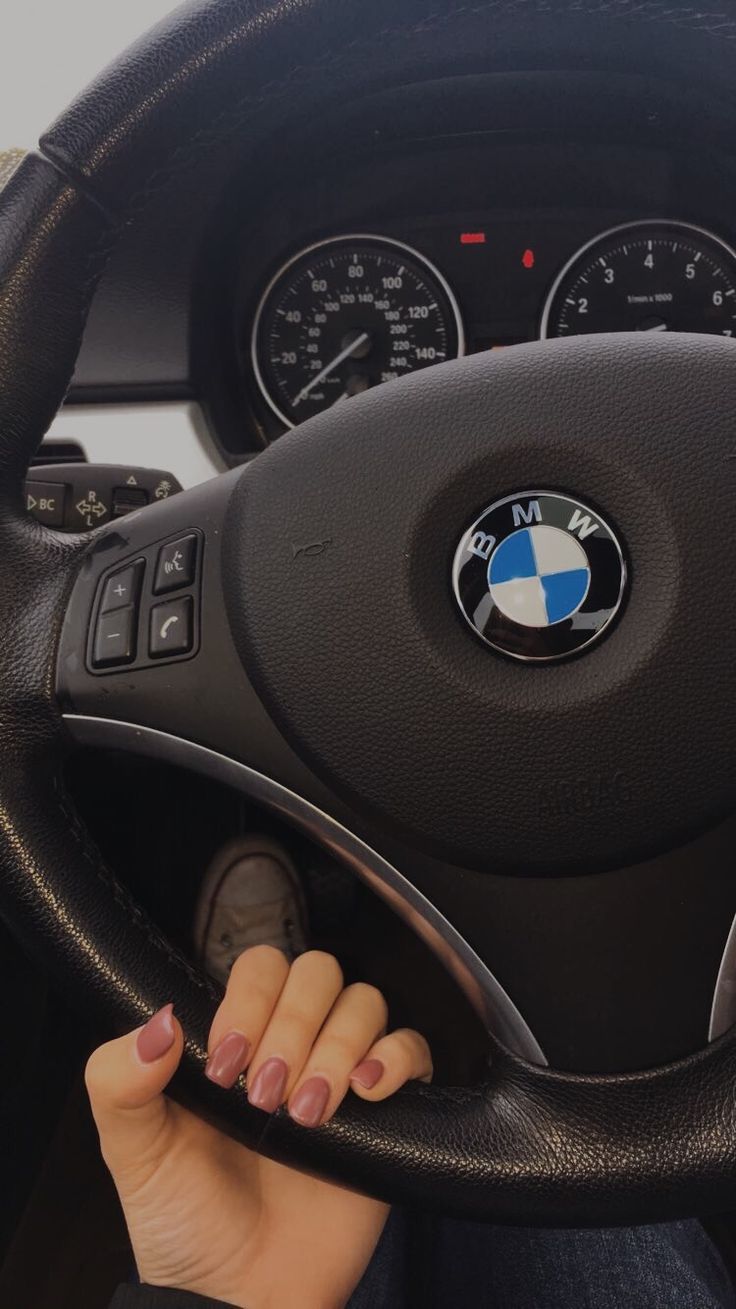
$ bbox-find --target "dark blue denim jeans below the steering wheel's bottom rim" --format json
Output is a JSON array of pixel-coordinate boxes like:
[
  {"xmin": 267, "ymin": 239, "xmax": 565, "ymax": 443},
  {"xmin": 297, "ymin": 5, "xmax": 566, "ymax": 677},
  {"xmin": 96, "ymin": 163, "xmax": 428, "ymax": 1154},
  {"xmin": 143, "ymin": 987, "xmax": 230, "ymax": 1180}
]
[{"xmin": 348, "ymin": 1210, "xmax": 736, "ymax": 1309}]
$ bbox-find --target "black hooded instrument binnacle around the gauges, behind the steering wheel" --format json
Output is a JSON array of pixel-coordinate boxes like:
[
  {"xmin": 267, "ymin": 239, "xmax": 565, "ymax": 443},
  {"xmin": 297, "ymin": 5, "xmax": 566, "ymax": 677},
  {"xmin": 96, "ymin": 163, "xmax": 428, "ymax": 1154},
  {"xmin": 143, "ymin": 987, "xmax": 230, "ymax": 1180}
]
[{"xmin": 215, "ymin": 100, "xmax": 736, "ymax": 442}]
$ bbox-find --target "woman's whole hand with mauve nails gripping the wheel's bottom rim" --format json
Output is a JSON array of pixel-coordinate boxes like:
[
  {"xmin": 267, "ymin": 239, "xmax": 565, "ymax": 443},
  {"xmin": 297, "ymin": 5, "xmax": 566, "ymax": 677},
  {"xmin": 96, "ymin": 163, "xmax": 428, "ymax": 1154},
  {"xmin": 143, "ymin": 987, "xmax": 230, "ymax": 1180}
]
[{"xmin": 86, "ymin": 945, "xmax": 432, "ymax": 1309}]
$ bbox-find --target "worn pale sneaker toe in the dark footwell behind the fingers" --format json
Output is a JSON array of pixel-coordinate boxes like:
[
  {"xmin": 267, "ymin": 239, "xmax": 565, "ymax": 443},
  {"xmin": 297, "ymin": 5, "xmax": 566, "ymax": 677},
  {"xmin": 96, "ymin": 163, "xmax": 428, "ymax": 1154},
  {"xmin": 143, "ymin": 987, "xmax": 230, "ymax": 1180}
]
[{"xmin": 194, "ymin": 835, "xmax": 308, "ymax": 983}]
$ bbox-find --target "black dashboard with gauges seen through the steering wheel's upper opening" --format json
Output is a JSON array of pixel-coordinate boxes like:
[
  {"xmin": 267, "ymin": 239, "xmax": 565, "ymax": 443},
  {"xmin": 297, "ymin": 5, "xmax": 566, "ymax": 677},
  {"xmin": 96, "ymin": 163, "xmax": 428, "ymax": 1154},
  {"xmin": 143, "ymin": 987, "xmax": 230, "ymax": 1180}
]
[{"xmin": 44, "ymin": 72, "xmax": 736, "ymax": 486}]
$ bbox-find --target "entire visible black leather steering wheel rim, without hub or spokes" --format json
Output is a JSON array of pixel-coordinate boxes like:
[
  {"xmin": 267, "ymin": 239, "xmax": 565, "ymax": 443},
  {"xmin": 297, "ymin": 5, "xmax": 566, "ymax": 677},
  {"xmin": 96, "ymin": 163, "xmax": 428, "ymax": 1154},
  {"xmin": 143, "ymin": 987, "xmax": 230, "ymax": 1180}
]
[{"xmin": 0, "ymin": 0, "xmax": 736, "ymax": 1224}]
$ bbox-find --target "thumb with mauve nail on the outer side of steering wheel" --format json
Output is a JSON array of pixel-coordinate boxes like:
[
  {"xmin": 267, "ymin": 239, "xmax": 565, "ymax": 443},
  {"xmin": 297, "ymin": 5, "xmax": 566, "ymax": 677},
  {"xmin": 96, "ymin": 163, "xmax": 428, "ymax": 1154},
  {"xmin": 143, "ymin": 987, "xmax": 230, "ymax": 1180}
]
[{"xmin": 85, "ymin": 1004, "xmax": 183, "ymax": 1181}]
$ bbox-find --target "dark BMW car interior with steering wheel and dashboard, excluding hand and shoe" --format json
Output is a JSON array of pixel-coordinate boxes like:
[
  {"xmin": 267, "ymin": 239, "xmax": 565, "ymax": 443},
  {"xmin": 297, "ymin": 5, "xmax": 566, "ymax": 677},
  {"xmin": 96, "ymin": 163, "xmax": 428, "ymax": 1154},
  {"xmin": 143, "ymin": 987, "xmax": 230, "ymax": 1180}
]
[{"xmin": 7, "ymin": 0, "xmax": 736, "ymax": 1309}]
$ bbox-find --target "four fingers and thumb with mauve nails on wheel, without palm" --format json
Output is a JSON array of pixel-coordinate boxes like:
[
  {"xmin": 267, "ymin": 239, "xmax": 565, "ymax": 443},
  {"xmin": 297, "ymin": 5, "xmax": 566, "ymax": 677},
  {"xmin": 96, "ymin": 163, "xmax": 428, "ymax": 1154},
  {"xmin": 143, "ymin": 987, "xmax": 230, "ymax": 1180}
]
[{"xmin": 85, "ymin": 946, "xmax": 432, "ymax": 1157}]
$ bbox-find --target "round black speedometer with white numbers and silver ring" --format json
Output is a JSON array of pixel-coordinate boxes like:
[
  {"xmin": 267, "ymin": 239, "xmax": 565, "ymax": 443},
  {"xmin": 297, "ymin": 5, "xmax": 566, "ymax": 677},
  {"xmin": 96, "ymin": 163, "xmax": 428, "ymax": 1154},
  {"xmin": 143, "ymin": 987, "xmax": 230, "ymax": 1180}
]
[{"xmin": 253, "ymin": 236, "xmax": 464, "ymax": 427}]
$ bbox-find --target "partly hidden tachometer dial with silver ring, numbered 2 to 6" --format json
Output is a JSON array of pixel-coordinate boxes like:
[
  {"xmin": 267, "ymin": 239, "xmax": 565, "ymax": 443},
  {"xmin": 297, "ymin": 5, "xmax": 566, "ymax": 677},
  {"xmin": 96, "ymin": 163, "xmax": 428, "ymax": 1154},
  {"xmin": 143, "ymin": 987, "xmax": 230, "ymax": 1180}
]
[{"xmin": 541, "ymin": 223, "xmax": 736, "ymax": 338}]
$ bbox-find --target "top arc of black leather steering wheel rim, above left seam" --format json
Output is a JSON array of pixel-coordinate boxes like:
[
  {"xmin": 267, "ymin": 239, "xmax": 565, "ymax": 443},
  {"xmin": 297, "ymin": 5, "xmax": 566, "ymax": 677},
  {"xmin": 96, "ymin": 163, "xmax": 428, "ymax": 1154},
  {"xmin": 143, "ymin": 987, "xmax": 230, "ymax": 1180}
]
[{"xmin": 41, "ymin": 0, "xmax": 736, "ymax": 213}]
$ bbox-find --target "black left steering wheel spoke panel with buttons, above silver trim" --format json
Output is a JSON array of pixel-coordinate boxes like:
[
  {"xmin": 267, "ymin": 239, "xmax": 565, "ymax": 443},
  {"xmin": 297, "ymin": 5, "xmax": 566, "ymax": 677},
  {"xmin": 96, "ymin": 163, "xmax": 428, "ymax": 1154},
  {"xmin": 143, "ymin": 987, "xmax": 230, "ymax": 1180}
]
[{"xmin": 58, "ymin": 470, "xmax": 281, "ymax": 778}]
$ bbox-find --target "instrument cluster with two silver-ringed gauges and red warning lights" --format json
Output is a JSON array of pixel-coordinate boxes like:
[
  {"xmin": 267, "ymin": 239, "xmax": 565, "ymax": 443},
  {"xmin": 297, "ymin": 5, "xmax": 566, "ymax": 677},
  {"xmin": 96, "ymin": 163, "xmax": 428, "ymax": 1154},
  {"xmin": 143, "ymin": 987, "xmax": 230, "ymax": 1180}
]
[{"xmin": 246, "ymin": 213, "xmax": 736, "ymax": 435}]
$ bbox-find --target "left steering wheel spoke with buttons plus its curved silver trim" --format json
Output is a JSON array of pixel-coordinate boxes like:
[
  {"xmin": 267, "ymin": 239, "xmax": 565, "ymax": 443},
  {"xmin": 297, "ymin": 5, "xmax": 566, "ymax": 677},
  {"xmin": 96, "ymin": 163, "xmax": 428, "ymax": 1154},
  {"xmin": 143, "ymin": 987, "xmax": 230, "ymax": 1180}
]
[{"xmin": 58, "ymin": 470, "xmax": 543, "ymax": 1063}]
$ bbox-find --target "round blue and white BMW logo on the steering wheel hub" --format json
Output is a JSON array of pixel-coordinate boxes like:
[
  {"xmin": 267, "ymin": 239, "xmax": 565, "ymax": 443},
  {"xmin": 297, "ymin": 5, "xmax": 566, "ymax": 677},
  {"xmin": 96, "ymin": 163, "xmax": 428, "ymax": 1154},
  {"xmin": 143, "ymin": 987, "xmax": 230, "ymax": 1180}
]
[{"xmin": 452, "ymin": 491, "xmax": 626, "ymax": 662}]
